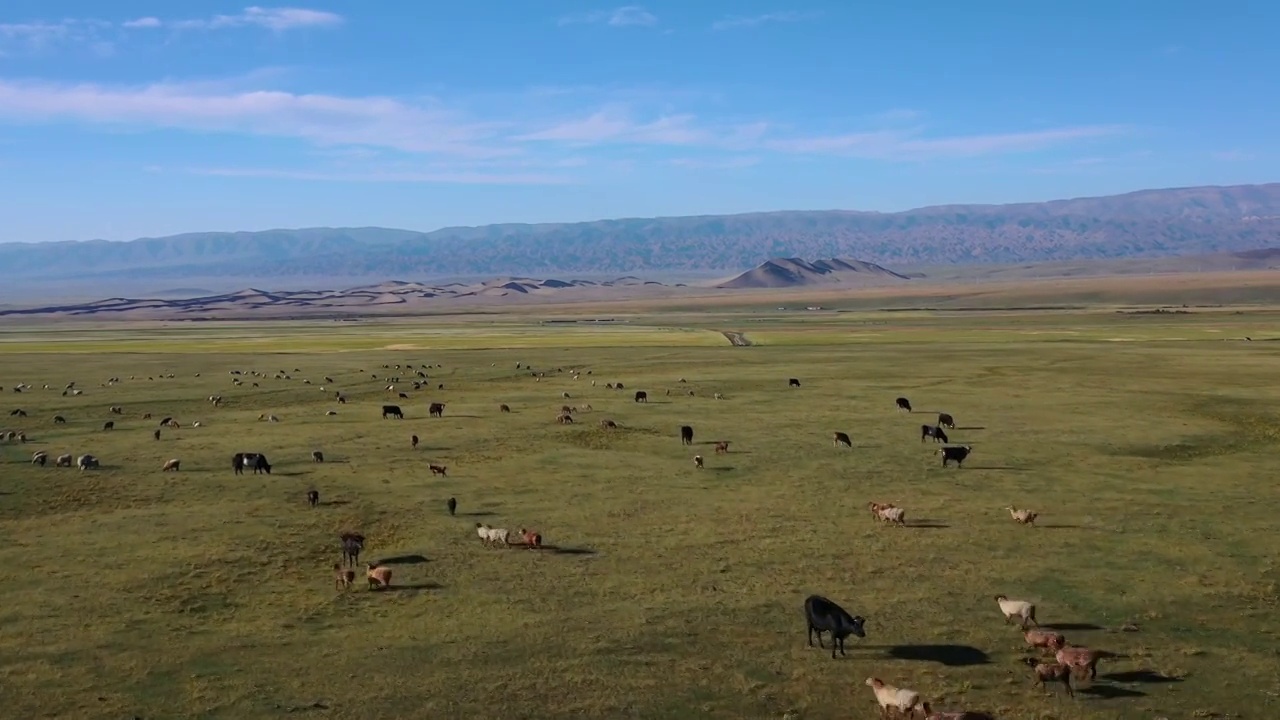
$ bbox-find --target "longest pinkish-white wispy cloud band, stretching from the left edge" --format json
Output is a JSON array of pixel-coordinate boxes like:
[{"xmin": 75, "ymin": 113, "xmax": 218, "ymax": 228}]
[{"xmin": 0, "ymin": 73, "xmax": 1128, "ymax": 184}]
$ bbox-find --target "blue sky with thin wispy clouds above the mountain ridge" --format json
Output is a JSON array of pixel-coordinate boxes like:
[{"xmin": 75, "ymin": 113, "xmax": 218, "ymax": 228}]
[{"xmin": 0, "ymin": 0, "xmax": 1280, "ymax": 241}]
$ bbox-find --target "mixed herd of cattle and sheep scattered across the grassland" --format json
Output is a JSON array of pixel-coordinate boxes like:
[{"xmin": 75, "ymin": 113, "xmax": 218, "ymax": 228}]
[{"xmin": 0, "ymin": 364, "xmax": 1131, "ymax": 720}]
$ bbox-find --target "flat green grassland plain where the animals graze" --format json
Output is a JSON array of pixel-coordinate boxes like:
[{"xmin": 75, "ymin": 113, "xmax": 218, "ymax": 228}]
[{"xmin": 0, "ymin": 307, "xmax": 1280, "ymax": 720}]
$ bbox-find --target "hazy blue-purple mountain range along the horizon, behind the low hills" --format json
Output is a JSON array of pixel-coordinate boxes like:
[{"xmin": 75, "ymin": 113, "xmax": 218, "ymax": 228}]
[{"xmin": 0, "ymin": 183, "xmax": 1280, "ymax": 283}]
